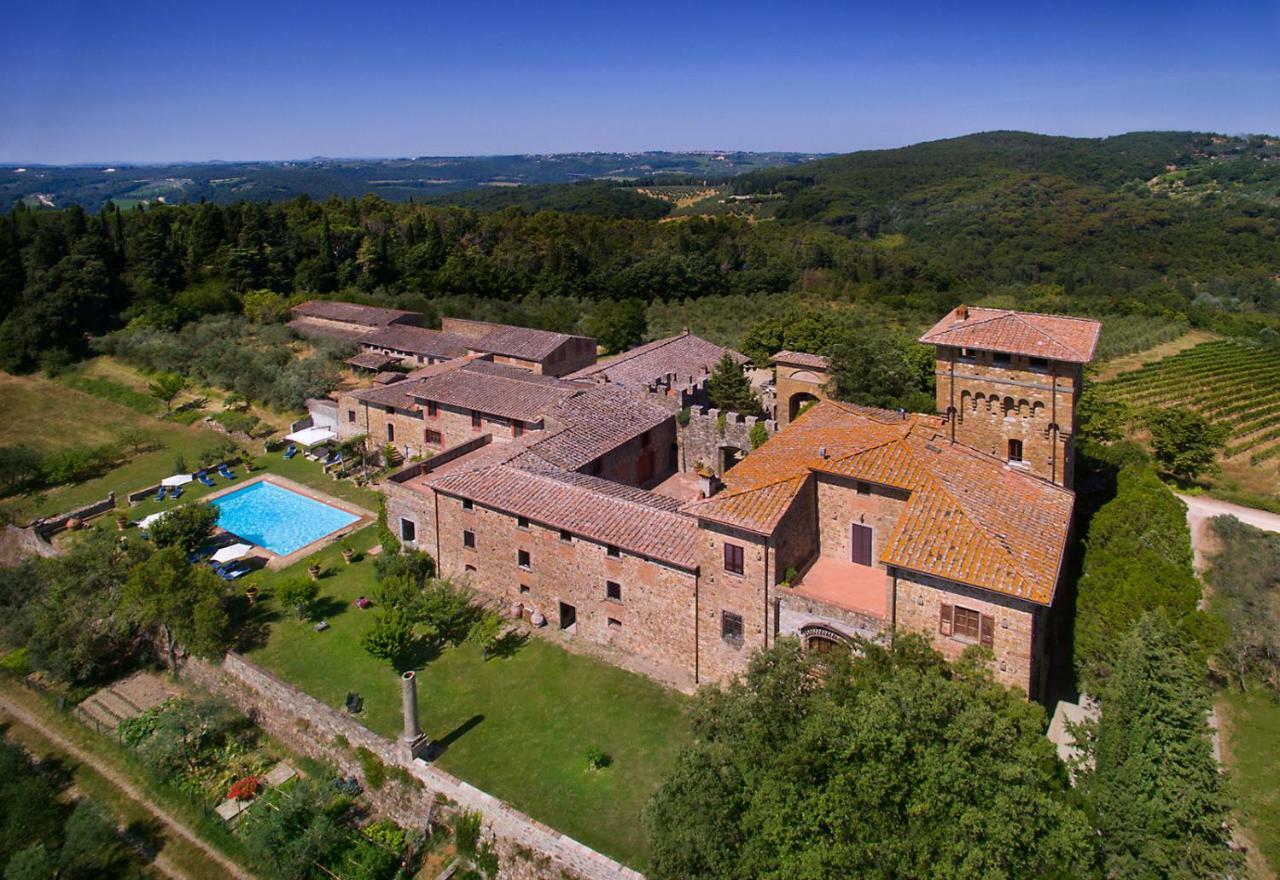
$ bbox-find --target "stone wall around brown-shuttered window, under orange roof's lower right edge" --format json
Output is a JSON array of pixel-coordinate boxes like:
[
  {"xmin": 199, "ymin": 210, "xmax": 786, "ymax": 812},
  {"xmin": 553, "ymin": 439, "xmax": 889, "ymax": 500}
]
[{"xmin": 891, "ymin": 569, "xmax": 1044, "ymax": 696}]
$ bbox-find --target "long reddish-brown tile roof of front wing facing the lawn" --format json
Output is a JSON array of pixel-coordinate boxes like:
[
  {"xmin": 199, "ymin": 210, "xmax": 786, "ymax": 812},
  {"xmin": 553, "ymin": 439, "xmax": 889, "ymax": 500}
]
[{"xmin": 422, "ymin": 464, "xmax": 698, "ymax": 570}]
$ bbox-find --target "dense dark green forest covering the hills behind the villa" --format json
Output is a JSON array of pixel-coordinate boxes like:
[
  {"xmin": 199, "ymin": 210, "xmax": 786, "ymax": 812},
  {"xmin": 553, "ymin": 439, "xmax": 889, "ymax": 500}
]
[{"xmin": 0, "ymin": 133, "xmax": 1280, "ymax": 372}]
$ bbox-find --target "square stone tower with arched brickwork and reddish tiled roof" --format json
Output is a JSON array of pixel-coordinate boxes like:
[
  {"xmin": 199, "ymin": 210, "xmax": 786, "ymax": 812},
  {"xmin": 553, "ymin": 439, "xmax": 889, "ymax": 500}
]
[{"xmin": 920, "ymin": 306, "xmax": 1102, "ymax": 489}]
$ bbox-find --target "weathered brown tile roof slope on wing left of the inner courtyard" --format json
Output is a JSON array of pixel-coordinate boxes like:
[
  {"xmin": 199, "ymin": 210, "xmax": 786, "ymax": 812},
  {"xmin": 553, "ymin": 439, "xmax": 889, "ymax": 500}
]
[{"xmin": 530, "ymin": 385, "xmax": 672, "ymax": 471}]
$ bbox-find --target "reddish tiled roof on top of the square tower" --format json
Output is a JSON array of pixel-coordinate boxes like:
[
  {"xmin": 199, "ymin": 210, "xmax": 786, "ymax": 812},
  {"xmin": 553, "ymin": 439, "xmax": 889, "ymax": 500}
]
[{"xmin": 920, "ymin": 306, "xmax": 1102, "ymax": 363}]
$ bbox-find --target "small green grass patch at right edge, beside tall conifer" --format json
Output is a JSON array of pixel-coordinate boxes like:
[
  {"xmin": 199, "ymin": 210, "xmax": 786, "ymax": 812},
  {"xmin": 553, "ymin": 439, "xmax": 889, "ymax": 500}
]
[{"xmin": 1221, "ymin": 686, "xmax": 1280, "ymax": 874}]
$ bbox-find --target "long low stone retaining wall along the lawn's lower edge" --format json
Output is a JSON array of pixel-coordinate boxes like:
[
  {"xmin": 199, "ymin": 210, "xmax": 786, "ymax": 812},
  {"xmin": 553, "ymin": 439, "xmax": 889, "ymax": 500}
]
[{"xmin": 184, "ymin": 654, "xmax": 644, "ymax": 880}]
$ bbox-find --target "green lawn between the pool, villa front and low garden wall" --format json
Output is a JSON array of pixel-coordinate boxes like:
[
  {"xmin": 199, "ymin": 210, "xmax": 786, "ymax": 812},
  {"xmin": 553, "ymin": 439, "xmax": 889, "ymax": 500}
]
[{"xmin": 246, "ymin": 528, "xmax": 690, "ymax": 868}]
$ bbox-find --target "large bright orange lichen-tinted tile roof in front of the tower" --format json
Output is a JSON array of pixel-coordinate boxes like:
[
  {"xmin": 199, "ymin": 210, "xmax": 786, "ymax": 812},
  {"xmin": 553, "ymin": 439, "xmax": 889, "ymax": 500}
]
[{"xmin": 684, "ymin": 402, "xmax": 1075, "ymax": 605}]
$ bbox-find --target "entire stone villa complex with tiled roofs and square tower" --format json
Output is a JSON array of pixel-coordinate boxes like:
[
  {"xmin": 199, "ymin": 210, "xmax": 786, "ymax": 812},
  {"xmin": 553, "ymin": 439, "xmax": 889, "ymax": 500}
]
[{"xmin": 294, "ymin": 303, "xmax": 1100, "ymax": 697}]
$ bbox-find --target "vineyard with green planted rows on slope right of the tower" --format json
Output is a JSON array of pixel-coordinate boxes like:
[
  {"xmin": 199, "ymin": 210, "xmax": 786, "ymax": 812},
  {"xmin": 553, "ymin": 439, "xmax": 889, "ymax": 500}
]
[{"xmin": 1098, "ymin": 339, "xmax": 1280, "ymax": 464}]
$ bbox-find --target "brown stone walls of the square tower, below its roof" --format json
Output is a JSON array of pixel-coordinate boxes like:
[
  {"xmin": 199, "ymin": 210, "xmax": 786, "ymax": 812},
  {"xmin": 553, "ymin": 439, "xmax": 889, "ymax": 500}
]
[{"xmin": 937, "ymin": 347, "xmax": 1082, "ymax": 487}]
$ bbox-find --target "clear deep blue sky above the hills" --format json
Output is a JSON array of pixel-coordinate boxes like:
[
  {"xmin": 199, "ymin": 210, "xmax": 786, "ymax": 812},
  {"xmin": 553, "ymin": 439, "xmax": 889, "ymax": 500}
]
[{"xmin": 0, "ymin": 0, "xmax": 1280, "ymax": 162}]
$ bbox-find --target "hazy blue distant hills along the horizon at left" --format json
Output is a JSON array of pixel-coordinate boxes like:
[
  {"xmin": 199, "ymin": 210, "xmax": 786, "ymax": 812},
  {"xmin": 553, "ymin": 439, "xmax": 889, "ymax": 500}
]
[{"xmin": 0, "ymin": 151, "xmax": 815, "ymax": 211}]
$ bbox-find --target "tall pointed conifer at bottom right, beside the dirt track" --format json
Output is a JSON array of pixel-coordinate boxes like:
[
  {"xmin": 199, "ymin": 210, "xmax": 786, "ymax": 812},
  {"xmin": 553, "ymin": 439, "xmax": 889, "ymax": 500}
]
[{"xmin": 1080, "ymin": 611, "xmax": 1240, "ymax": 880}]
